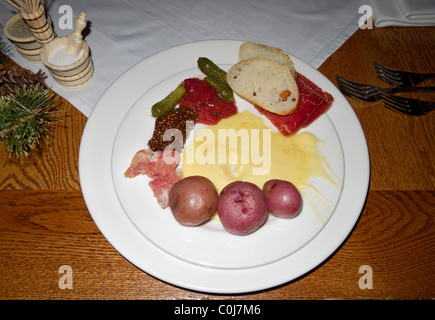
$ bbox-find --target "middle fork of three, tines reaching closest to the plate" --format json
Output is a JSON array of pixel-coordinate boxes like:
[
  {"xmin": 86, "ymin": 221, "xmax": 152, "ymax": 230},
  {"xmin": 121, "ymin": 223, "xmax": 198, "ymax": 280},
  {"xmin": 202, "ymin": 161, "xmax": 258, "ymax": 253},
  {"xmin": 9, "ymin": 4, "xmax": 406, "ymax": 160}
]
[{"xmin": 335, "ymin": 75, "xmax": 435, "ymax": 102}]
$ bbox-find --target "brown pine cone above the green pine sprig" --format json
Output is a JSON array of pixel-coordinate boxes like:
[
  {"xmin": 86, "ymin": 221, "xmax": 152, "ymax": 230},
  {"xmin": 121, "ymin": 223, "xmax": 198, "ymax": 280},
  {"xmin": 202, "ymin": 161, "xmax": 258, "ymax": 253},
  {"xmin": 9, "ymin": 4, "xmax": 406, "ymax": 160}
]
[{"xmin": 0, "ymin": 64, "xmax": 47, "ymax": 96}]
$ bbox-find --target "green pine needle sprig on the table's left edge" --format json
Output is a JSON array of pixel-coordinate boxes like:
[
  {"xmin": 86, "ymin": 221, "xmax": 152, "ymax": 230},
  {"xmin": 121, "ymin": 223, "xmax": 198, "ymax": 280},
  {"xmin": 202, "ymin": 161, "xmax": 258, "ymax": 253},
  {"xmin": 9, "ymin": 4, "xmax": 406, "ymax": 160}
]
[{"xmin": 0, "ymin": 85, "xmax": 60, "ymax": 158}]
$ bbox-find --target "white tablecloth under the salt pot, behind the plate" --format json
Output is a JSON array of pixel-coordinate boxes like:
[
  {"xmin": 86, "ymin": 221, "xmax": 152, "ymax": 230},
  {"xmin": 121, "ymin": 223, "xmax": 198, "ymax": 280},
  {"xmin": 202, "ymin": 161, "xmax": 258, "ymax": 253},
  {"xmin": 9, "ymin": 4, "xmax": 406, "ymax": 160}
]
[{"xmin": 0, "ymin": 0, "xmax": 364, "ymax": 116}]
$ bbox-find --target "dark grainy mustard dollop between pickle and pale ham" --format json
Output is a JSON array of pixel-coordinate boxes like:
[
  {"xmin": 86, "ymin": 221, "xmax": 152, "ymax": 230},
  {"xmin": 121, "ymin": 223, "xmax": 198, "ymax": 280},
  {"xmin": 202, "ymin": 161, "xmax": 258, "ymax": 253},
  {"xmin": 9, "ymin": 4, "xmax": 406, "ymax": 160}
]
[{"xmin": 148, "ymin": 107, "xmax": 198, "ymax": 152}]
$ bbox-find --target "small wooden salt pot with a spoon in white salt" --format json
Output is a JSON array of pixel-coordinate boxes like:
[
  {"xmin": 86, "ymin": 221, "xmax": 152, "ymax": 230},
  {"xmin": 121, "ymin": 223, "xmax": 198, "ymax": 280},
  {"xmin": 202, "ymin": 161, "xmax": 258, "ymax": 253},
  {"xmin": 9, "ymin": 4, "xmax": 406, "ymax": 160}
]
[{"xmin": 41, "ymin": 13, "xmax": 94, "ymax": 88}]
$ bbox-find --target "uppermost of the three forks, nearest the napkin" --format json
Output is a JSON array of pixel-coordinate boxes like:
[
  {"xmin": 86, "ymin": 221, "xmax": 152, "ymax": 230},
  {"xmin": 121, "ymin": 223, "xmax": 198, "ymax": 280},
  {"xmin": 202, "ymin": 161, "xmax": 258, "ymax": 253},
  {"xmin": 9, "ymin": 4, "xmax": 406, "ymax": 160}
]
[{"xmin": 373, "ymin": 62, "xmax": 435, "ymax": 88}]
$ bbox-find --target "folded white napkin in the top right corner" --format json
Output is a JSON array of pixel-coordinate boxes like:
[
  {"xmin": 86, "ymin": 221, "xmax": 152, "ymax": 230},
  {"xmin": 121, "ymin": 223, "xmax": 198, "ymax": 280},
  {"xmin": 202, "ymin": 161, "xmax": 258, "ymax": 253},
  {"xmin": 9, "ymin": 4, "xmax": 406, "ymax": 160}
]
[{"xmin": 367, "ymin": 0, "xmax": 435, "ymax": 27}]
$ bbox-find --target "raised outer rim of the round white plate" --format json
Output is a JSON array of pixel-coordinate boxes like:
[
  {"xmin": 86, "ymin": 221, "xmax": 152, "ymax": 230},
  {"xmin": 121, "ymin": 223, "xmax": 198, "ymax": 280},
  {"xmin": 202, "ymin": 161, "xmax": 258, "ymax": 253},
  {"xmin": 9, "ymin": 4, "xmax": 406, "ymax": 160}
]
[{"xmin": 79, "ymin": 40, "xmax": 370, "ymax": 294}]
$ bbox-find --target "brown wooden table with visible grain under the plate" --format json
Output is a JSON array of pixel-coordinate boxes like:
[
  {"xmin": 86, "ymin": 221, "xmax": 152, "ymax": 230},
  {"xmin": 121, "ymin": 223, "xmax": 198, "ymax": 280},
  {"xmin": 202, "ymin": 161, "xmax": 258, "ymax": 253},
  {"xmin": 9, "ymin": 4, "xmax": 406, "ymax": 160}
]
[{"xmin": 0, "ymin": 27, "xmax": 435, "ymax": 300}]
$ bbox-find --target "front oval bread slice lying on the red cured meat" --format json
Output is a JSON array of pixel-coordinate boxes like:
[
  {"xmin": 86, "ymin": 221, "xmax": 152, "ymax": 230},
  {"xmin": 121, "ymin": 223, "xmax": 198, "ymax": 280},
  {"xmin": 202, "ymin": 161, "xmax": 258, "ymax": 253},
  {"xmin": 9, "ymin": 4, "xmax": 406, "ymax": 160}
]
[{"xmin": 227, "ymin": 58, "xmax": 299, "ymax": 115}]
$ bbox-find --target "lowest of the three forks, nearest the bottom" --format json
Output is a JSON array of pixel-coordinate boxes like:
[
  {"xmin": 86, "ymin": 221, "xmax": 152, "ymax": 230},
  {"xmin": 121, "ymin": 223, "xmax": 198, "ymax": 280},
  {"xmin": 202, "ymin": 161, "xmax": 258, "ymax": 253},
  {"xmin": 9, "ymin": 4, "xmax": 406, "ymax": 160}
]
[{"xmin": 381, "ymin": 92, "xmax": 435, "ymax": 116}]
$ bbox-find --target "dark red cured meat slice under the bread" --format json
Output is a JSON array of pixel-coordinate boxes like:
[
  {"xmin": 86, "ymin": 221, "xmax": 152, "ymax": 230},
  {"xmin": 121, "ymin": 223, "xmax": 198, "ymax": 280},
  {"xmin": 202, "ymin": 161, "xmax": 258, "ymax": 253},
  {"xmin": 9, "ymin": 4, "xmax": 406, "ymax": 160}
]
[{"xmin": 256, "ymin": 74, "xmax": 334, "ymax": 136}]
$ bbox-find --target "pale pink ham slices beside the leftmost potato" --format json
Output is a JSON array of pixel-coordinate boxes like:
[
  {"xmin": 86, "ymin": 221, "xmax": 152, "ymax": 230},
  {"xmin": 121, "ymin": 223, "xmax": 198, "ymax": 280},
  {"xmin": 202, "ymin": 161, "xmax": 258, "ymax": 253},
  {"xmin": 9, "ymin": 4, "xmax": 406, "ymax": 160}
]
[{"xmin": 124, "ymin": 149, "xmax": 181, "ymax": 208}]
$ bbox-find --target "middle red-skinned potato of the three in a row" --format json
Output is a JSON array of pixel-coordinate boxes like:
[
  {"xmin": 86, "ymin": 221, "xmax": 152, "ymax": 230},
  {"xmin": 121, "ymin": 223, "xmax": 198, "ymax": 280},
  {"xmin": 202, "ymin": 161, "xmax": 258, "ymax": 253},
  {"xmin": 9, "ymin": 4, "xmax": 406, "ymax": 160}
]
[{"xmin": 217, "ymin": 181, "xmax": 267, "ymax": 235}]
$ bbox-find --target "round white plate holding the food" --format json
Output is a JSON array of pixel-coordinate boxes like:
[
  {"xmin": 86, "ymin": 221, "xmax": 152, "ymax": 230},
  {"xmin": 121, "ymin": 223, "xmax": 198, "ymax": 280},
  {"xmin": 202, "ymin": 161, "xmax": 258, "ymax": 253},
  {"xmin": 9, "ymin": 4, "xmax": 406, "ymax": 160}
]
[{"xmin": 79, "ymin": 40, "xmax": 369, "ymax": 294}]
